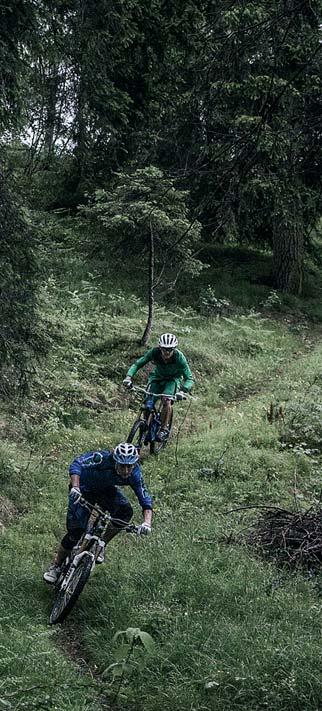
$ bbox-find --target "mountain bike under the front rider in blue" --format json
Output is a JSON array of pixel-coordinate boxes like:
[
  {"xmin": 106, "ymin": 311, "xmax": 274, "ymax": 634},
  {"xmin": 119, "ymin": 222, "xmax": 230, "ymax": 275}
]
[{"xmin": 49, "ymin": 497, "xmax": 139, "ymax": 625}]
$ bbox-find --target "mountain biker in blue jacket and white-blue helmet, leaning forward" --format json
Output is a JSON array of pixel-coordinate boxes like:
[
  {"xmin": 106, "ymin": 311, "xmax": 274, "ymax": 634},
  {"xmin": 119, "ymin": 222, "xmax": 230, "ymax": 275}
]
[{"xmin": 44, "ymin": 442, "xmax": 152, "ymax": 583}]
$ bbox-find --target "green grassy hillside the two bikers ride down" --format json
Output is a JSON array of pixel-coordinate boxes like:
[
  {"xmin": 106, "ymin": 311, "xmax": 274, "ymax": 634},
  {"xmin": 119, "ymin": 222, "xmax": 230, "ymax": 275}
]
[{"xmin": 0, "ymin": 231, "xmax": 322, "ymax": 711}]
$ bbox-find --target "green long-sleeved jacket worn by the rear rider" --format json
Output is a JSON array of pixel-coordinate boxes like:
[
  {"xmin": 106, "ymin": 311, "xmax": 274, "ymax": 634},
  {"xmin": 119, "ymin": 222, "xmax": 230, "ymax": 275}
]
[{"xmin": 126, "ymin": 348, "xmax": 193, "ymax": 392}]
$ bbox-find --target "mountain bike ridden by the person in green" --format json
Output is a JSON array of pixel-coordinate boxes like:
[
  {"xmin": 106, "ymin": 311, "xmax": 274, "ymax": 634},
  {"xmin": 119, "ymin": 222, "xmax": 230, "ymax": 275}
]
[{"xmin": 126, "ymin": 385, "xmax": 186, "ymax": 454}]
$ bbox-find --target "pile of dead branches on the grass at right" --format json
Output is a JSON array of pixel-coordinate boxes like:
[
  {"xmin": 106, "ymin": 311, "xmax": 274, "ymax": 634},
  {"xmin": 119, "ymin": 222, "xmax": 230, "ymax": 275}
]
[{"xmin": 247, "ymin": 508, "xmax": 322, "ymax": 568}]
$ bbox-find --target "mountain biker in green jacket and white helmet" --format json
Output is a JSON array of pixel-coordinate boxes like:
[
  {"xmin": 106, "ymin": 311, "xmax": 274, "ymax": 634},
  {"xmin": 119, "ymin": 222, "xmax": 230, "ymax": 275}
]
[{"xmin": 123, "ymin": 333, "xmax": 194, "ymax": 441}]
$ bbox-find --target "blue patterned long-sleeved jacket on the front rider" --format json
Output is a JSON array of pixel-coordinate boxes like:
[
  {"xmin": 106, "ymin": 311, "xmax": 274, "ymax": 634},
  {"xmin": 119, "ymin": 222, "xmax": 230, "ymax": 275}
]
[{"xmin": 69, "ymin": 449, "xmax": 152, "ymax": 511}]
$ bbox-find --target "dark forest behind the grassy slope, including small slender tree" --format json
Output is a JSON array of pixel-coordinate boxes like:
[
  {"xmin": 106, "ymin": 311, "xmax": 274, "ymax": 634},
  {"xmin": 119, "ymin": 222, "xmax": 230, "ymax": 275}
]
[{"xmin": 0, "ymin": 0, "xmax": 322, "ymax": 393}]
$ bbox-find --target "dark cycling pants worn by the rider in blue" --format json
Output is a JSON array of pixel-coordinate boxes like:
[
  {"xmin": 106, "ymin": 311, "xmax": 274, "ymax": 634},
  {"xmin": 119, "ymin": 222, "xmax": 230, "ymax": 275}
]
[{"xmin": 61, "ymin": 486, "xmax": 133, "ymax": 550}]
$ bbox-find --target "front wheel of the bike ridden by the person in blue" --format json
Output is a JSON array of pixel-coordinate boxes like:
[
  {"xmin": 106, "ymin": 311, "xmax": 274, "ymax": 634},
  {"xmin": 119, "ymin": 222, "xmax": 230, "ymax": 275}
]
[{"xmin": 49, "ymin": 555, "xmax": 93, "ymax": 625}]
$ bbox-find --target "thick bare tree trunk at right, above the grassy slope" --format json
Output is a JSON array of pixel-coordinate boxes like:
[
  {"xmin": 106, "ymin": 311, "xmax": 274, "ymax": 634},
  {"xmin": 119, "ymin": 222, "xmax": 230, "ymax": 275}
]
[{"xmin": 273, "ymin": 218, "xmax": 304, "ymax": 296}]
